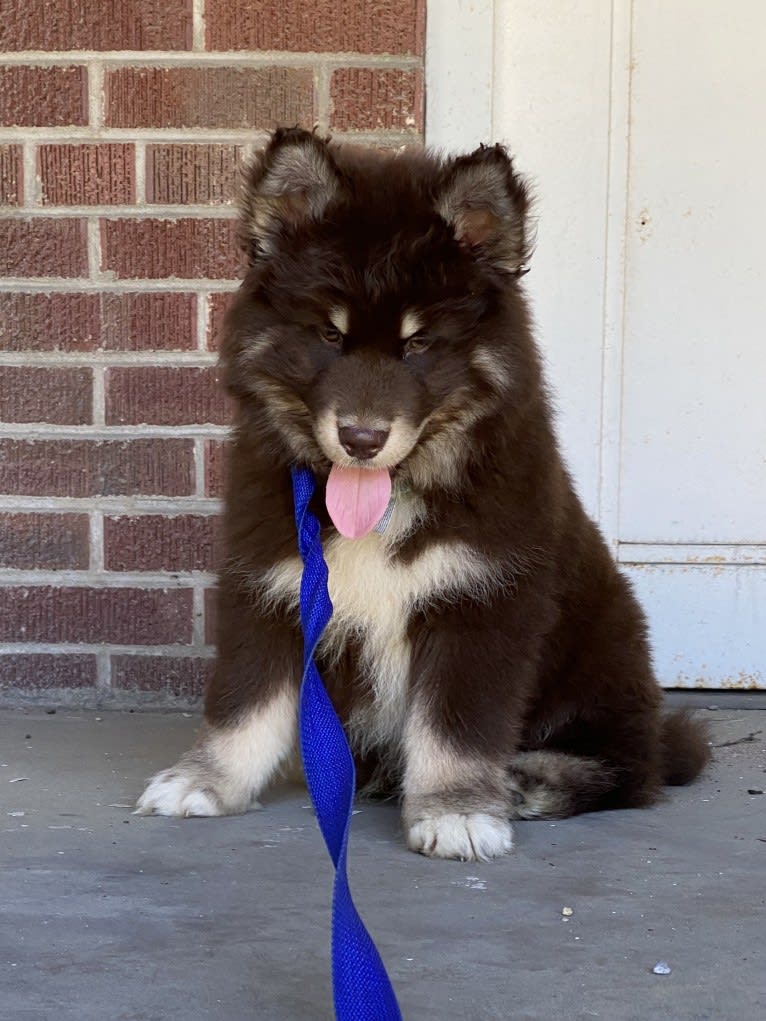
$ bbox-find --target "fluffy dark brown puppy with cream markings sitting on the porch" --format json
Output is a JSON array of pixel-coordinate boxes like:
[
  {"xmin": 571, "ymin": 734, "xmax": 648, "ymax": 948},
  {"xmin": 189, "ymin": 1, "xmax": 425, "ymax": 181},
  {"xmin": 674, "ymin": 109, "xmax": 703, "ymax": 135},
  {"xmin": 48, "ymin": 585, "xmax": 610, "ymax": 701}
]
[{"xmin": 134, "ymin": 130, "xmax": 708, "ymax": 860}]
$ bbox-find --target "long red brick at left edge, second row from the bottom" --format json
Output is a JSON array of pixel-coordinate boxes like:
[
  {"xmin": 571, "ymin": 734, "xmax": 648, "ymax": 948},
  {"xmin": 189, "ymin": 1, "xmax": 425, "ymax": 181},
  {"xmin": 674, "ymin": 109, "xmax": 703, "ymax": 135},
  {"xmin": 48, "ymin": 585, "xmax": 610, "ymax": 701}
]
[{"xmin": 0, "ymin": 585, "xmax": 192, "ymax": 645}]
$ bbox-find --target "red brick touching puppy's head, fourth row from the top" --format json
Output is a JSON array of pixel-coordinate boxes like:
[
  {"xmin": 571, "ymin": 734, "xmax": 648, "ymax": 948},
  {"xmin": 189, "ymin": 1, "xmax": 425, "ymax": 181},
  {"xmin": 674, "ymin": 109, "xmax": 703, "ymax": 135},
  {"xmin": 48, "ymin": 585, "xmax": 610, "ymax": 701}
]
[{"xmin": 101, "ymin": 218, "xmax": 240, "ymax": 280}]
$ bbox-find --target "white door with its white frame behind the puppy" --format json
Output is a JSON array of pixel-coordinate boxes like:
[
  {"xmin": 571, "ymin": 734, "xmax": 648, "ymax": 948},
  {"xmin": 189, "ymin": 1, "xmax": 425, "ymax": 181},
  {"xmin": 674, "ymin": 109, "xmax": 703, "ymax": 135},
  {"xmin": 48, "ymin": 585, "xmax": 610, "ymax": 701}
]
[{"xmin": 427, "ymin": 0, "xmax": 766, "ymax": 688}]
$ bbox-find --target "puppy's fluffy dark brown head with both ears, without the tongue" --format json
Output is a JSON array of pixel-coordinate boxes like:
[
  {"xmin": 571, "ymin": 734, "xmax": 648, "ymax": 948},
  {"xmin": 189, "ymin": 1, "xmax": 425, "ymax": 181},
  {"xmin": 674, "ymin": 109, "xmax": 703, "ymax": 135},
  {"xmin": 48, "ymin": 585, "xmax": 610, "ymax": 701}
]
[{"xmin": 223, "ymin": 132, "xmax": 526, "ymax": 486}]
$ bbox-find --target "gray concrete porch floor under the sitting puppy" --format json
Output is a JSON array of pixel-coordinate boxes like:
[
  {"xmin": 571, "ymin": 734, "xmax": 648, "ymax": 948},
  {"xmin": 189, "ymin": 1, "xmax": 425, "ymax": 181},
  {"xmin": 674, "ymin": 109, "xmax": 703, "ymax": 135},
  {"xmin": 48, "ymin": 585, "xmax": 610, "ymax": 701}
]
[{"xmin": 0, "ymin": 709, "xmax": 766, "ymax": 1021}]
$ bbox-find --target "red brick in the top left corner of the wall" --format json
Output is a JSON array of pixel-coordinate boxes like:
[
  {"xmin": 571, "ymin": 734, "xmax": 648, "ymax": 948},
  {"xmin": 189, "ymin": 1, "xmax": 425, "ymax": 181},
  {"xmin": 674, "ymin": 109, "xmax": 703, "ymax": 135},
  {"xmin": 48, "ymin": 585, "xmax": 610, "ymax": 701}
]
[{"xmin": 0, "ymin": 0, "xmax": 192, "ymax": 52}]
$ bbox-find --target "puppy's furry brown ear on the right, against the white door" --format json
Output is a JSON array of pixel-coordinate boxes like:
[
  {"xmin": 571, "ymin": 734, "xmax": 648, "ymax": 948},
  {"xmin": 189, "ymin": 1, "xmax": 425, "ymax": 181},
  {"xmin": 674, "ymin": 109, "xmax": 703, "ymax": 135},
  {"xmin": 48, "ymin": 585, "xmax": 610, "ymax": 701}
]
[{"xmin": 436, "ymin": 145, "xmax": 531, "ymax": 276}]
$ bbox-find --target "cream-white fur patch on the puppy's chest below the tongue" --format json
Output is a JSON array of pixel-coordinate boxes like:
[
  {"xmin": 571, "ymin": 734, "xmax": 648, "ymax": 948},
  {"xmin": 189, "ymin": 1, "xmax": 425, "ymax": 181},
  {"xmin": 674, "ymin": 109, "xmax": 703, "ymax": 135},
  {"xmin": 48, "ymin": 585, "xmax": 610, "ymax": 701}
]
[{"xmin": 261, "ymin": 494, "xmax": 494, "ymax": 749}]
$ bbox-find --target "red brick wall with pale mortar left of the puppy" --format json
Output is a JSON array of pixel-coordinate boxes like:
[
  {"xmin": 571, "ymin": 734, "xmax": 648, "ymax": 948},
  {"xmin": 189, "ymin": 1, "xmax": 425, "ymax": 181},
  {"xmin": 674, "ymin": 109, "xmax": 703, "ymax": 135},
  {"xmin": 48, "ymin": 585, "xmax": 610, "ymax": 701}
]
[{"xmin": 0, "ymin": 0, "xmax": 425, "ymax": 704}]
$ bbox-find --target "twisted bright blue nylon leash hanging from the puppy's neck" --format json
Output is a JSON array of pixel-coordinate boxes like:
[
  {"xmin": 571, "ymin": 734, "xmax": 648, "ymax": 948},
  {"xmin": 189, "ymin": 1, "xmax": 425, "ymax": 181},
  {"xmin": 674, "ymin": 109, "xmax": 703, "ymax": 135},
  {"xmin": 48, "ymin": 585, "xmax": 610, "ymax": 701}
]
[{"xmin": 292, "ymin": 468, "xmax": 401, "ymax": 1021}]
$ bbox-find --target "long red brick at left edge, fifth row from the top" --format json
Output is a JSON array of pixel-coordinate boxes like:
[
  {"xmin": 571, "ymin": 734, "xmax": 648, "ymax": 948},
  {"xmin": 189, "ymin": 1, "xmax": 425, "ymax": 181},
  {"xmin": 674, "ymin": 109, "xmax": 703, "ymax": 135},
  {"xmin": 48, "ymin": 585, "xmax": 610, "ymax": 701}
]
[{"xmin": 0, "ymin": 291, "xmax": 197, "ymax": 351}]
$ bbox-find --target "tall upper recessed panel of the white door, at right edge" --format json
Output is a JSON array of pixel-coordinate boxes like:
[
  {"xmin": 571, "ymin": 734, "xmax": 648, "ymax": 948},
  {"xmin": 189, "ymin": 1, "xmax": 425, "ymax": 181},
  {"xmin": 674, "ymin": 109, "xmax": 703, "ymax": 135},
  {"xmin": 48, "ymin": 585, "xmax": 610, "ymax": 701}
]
[{"xmin": 619, "ymin": 0, "xmax": 766, "ymax": 543}]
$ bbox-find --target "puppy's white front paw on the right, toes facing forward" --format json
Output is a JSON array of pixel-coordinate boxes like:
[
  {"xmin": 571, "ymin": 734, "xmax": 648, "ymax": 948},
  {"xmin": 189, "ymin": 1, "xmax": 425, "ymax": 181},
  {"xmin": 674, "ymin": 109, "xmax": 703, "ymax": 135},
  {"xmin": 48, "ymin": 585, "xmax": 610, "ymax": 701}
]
[{"xmin": 406, "ymin": 812, "xmax": 514, "ymax": 862}]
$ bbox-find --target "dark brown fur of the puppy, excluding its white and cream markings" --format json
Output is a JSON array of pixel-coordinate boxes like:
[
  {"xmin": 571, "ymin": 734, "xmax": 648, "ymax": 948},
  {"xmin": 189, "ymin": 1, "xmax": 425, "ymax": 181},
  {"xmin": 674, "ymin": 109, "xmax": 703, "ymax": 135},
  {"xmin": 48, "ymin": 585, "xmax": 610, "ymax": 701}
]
[{"xmin": 136, "ymin": 131, "xmax": 709, "ymax": 857}]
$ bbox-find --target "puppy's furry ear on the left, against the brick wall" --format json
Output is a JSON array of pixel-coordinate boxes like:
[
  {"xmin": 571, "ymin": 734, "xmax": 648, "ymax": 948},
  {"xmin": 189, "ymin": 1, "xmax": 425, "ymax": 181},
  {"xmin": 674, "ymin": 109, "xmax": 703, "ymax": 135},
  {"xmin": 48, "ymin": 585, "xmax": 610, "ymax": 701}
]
[{"xmin": 240, "ymin": 128, "xmax": 341, "ymax": 262}]
